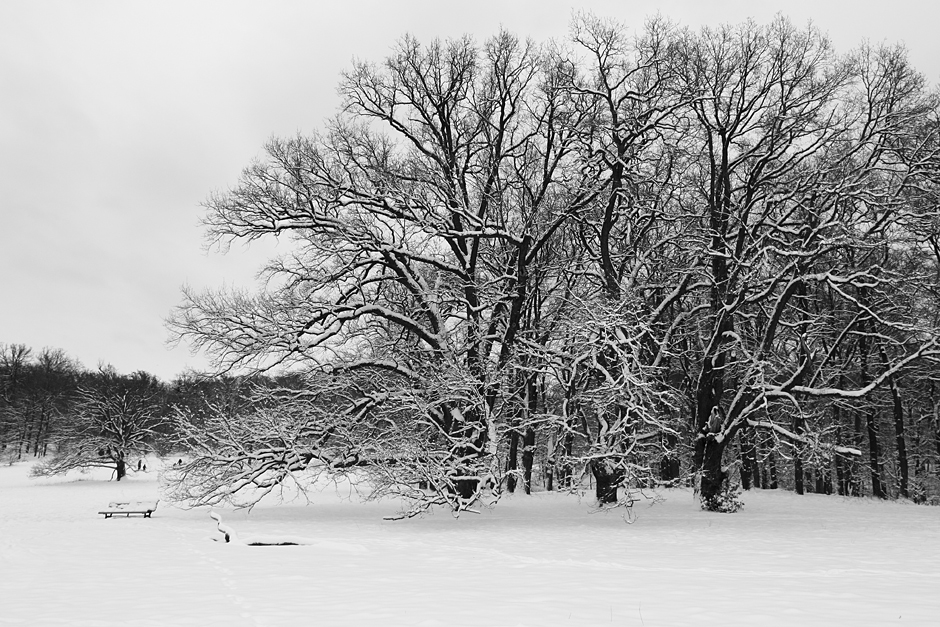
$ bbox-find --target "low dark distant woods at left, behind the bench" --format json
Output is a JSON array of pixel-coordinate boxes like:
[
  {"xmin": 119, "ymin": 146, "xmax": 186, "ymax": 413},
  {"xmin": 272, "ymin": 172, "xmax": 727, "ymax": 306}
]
[{"xmin": 0, "ymin": 343, "xmax": 260, "ymax": 481}]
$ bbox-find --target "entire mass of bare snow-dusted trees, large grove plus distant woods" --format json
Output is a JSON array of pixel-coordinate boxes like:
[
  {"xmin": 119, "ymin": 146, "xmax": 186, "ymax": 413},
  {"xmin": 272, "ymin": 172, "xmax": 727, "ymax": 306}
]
[{"xmin": 0, "ymin": 16, "xmax": 940, "ymax": 515}]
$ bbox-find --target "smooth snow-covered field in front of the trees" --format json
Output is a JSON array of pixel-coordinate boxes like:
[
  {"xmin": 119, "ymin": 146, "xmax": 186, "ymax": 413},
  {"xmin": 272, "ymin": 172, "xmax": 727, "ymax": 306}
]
[{"xmin": 0, "ymin": 464, "xmax": 940, "ymax": 627}]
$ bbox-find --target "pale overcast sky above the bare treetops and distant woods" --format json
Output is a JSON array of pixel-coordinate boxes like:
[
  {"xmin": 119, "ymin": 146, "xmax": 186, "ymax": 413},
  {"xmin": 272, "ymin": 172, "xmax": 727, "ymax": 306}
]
[{"xmin": 0, "ymin": 0, "xmax": 940, "ymax": 379}]
